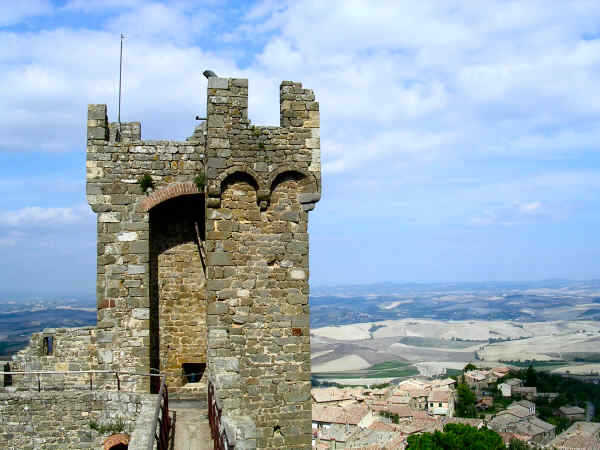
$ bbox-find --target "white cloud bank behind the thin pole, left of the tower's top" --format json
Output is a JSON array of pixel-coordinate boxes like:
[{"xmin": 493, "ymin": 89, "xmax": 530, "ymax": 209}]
[{"xmin": 0, "ymin": 29, "xmax": 246, "ymax": 151}]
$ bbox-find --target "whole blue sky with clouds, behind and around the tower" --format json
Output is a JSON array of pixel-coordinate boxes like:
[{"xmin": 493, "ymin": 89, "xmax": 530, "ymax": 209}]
[{"xmin": 0, "ymin": 0, "xmax": 600, "ymax": 295}]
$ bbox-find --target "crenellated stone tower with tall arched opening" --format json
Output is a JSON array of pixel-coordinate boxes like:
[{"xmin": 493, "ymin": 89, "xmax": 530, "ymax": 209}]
[{"xmin": 86, "ymin": 77, "xmax": 321, "ymax": 448}]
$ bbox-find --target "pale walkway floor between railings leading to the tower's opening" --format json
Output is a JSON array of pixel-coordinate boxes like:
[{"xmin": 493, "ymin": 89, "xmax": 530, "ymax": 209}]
[{"xmin": 169, "ymin": 398, "xmax": 214, "ymax": 450}]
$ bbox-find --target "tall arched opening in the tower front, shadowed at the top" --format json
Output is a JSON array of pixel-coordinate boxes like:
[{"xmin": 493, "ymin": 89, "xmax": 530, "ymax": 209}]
[{"xmin": 149, "ymin": 194, "xmax": 206, "ymax": 392}]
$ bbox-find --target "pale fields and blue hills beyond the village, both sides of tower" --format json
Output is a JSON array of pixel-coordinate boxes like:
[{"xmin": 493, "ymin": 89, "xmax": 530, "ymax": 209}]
[{"xmin": 0, "ymin": 280, "xmax": 600, "ymax": 383}]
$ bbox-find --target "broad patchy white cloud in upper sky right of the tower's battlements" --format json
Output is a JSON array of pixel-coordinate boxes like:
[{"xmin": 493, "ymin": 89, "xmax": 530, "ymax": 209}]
[{"xmin": 246, "ymin": 1, "xmax": 600, "ymax": 168}]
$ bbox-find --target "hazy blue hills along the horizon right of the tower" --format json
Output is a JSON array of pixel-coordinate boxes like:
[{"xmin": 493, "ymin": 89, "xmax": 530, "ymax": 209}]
[{"xmin": 310, "ymin": 280, "xmax": 600, "ymax": 328}]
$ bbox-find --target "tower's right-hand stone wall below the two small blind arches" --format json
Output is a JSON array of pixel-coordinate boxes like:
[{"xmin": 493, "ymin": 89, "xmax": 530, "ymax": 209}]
[{"xmin": 207, "ymin": 174, "xmax": 311, "ymax": 448}]
